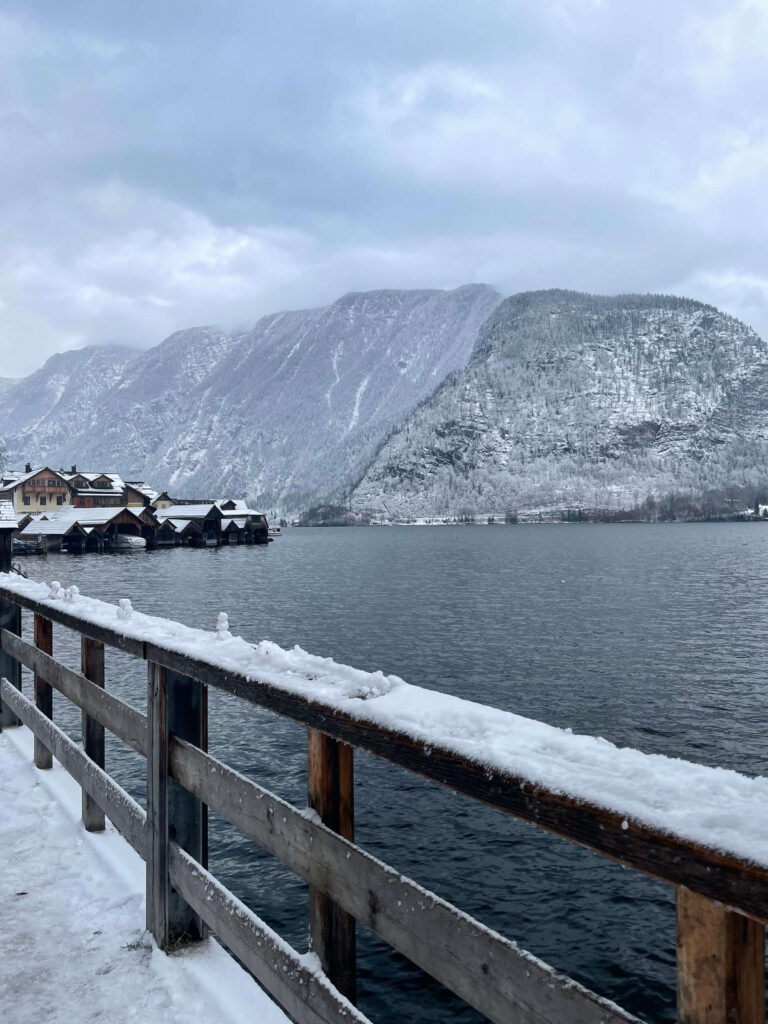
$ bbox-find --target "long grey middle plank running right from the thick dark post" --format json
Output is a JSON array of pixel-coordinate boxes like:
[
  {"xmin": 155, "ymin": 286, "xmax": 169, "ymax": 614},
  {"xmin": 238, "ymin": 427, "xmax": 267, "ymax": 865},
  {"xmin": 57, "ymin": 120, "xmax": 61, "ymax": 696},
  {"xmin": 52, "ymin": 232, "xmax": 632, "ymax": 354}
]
[{"xmin": 169, "ymin": 737, "xmax": 636, "ymax": 1024}]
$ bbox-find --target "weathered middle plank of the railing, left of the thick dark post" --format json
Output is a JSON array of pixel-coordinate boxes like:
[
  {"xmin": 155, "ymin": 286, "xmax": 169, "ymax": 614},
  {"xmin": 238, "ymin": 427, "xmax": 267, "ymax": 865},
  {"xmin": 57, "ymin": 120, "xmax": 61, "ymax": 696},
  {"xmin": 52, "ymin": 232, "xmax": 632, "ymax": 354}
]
[{"xmin": 0, "ymin": 630, "xmax": 146, "ymax": 756}]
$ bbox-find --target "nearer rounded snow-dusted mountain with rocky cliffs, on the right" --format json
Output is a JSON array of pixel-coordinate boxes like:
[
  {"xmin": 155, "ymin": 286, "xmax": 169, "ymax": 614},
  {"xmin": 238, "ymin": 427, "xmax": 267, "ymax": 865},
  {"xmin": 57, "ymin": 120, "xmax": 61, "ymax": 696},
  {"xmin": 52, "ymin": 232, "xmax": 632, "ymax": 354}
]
[{"xmin": 352, "ymin": 291, "xmax": 768, "ymax": 516}]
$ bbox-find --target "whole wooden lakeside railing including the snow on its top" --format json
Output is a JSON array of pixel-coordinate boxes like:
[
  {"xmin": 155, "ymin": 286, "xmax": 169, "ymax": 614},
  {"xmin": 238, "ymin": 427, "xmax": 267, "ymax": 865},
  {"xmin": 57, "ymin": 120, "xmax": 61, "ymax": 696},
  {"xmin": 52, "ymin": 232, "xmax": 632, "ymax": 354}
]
[{"xmin": 0, "ymin": 574, "xmax": 768, "ymax": 1024}]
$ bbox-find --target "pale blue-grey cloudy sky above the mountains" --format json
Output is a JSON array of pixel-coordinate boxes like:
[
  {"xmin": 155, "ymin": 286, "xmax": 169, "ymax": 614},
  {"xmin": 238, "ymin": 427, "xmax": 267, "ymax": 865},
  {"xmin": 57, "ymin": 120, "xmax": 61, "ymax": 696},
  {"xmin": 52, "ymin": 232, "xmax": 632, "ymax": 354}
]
[{"xmin": 0, "ymin": 0, "xmax": 768, "ymax": 377}]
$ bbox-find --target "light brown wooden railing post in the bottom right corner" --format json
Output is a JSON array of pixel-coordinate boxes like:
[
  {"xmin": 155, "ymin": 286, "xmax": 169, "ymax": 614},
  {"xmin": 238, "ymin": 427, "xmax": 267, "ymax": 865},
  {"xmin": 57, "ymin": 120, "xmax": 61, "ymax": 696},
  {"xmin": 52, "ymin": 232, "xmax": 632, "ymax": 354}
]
[{"xmin": 677, "ymin": 886, "xmax": 765, "ymax": 1024}]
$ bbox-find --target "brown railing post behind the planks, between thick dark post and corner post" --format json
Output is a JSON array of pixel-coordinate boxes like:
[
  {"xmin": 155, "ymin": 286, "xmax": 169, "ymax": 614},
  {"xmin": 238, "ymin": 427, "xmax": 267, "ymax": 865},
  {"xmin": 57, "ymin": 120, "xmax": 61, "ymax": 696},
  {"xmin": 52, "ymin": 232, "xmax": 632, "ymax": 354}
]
[{"xmin": 307, "ymin": 729, "xmax": 357, "ymax": 1002}]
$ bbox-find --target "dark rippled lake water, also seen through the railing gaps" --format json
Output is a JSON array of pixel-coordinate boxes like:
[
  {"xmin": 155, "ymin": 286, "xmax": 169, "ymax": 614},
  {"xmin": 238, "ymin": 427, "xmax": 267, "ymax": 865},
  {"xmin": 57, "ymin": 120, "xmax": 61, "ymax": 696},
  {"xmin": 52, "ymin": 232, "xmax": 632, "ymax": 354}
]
[{"xmin": 16, "ymin": 523, "xmax": 768, "ymax": 1024}]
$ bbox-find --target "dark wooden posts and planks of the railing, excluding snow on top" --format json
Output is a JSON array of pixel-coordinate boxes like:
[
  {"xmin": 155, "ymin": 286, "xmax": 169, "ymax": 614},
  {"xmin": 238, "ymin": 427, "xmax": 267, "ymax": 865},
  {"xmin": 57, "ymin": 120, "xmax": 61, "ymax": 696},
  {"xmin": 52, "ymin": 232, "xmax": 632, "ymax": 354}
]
[{"xmin": 0, "ymin": 578, "xmax": 768, "ymax": 1024}]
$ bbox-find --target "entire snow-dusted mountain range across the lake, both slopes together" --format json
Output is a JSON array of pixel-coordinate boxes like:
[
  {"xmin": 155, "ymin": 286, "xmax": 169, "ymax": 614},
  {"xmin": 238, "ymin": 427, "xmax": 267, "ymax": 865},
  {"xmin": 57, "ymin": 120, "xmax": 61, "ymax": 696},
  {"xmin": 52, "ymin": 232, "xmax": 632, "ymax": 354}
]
[{"xmin": 7, "ymin": 285, "xmax": 768, "ymax": 516}]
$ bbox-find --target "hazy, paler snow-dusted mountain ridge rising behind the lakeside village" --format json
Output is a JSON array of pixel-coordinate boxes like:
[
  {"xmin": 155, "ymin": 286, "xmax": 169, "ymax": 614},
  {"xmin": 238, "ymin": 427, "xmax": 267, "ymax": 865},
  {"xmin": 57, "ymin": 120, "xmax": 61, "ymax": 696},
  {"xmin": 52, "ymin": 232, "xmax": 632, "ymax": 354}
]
[{"xmin": 0, "ymin": 285, "xmax": 502, "ymax": 509}]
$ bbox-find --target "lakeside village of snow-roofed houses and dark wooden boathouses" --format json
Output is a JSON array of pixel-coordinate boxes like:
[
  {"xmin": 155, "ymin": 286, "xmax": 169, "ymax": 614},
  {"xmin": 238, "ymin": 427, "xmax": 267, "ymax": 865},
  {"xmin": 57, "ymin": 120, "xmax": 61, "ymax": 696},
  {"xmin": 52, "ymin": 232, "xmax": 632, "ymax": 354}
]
[{"xmin": 0, "ymin": 463, "xmax": 280, "ymax": 554}]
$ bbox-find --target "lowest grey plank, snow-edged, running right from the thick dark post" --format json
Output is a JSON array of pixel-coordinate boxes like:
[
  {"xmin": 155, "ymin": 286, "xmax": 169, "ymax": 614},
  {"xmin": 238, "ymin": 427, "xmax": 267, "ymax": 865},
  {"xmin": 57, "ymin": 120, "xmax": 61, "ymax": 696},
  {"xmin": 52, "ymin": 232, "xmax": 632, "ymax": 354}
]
[{"xmin": 169, "ymin": 843, "xmax": 371, "ymax": 1024}]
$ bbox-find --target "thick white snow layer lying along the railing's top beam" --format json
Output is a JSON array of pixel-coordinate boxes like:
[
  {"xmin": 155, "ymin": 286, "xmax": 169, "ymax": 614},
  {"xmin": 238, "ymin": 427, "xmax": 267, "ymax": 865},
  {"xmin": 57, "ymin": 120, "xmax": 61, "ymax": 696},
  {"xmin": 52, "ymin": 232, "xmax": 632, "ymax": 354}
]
[{"xmin": 0, "ymin": 574, "xmax": 768, "ymax": 865}]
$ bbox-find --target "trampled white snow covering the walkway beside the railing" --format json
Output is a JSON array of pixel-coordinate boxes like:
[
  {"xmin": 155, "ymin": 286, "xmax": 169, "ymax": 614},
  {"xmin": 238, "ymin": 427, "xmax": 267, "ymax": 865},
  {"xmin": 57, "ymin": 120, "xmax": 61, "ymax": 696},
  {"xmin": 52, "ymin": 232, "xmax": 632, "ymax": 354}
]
[{"xmin": 0, "ymin": 728, "xmax": 288, "ymax": 1024}]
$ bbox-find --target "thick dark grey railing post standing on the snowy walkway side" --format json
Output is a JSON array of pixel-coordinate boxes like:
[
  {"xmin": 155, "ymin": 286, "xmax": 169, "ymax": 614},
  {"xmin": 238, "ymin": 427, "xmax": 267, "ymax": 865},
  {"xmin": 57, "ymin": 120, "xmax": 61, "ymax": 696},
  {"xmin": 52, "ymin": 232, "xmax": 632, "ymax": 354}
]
[{"xmin": 146, "ymin": 662, "xmax": 208, "ymax": 949}]
